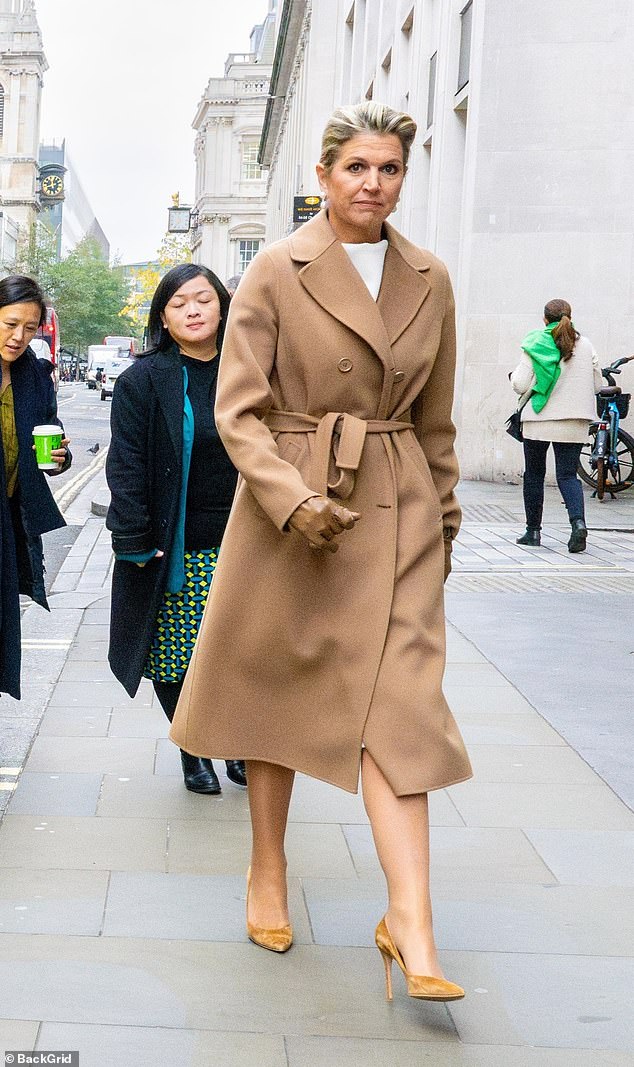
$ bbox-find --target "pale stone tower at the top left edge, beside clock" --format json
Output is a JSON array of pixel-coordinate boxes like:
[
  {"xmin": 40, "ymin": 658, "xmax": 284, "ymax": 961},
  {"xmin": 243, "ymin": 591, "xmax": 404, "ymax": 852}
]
[{"xmin": 0, "ymin": 0, "xmax": 47, "ymax": 267}]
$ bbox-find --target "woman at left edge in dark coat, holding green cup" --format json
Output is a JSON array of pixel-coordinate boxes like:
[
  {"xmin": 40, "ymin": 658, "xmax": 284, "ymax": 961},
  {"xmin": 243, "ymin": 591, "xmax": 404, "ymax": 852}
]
[{"xmin": 0, "ymin": 274, "xmax": 72, "ymax": 700}]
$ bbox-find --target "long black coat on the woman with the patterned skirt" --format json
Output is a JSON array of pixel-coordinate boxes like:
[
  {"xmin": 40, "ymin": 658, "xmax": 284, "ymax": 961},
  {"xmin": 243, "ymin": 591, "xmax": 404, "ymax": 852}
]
[{"xmin": 106, "ymin": 351, "xmax": 185, "ymax": 697}]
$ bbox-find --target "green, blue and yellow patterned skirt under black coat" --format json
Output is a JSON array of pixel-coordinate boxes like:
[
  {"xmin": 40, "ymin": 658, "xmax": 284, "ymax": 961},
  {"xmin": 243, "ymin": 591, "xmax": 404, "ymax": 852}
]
[{"xmin": 143, "ymin": 548, "xmax": 220, "ymax": 682}]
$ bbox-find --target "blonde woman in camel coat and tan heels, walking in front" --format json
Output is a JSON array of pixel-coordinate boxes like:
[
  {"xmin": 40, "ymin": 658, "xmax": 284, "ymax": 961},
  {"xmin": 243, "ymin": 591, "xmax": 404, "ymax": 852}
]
[{"xmin": 171, "ymin": 102, "xmax": 471, "ymax": 999}]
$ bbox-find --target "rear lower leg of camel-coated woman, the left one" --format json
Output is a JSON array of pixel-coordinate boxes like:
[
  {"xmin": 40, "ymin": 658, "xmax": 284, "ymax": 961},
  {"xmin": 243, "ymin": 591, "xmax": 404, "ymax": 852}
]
[{"xmin": 247, "ymin": 760, "xmax": 295, "ymax": 929}]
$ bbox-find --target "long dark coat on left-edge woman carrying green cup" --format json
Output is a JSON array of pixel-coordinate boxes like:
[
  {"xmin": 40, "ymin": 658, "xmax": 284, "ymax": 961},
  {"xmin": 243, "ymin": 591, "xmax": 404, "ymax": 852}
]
[{"xmin": 0, "ymin": 348, "xmax": 72, "ymax": 700}]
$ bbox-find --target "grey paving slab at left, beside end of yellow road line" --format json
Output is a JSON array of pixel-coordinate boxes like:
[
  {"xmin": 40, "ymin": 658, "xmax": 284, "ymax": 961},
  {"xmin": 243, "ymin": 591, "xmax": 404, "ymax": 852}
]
[{"xmin": 11, "ymin": 770, "xmax": 101, "ymax": 815}]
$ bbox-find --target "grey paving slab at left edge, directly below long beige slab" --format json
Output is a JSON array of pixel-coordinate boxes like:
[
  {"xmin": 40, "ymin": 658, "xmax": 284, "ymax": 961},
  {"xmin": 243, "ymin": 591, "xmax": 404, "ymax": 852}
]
[{"xmin": 0, "ymin": 856, "xmax": 109, "ymax": 934}]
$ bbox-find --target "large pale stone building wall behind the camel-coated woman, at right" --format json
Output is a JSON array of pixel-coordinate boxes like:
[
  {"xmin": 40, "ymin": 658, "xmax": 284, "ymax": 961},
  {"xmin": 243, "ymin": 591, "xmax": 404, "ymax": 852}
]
[{"xmin": 260, "ymin": 0, "xmax": 634, "ymax": 479}]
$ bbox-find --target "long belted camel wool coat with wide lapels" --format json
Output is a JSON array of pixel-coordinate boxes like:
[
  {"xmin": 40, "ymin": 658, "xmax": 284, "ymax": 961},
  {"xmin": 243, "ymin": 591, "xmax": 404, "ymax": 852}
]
[{"xmin": 171, "ymin": 211, "xmax": 471, "ymax": 796}]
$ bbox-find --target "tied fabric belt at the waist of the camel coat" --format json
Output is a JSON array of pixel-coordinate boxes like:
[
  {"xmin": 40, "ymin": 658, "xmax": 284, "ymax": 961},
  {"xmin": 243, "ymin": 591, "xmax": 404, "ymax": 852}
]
[{"xmin": 264, "ymin": 408, "xmax": 414, "ymax": 500}]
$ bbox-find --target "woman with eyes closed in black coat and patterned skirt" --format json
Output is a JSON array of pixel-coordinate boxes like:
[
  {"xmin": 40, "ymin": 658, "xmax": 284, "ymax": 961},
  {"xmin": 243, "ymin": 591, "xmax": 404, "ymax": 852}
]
[{"xmin": 106, "ymin": 264, "xmax": 247, "ymax": 794}]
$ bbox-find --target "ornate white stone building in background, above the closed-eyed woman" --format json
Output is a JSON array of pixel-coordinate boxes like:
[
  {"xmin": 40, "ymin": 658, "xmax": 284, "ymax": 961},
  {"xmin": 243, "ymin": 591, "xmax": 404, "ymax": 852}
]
[{"xmin": 192, "ymin": 0, "xmax": 275, "ymax": 281}]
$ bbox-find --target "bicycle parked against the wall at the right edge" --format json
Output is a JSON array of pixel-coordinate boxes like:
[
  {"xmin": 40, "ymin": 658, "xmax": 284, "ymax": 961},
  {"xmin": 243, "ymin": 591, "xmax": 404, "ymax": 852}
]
[{"xmin": 577, "ymin": 355, "xmax": 634, "ymax": 500}]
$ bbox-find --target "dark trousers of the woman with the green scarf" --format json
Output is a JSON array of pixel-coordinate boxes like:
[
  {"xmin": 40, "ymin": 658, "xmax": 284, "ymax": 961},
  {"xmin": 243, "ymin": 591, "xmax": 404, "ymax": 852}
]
[{"xmin": 524, "ymin": 440, "xmax": 585, "ymax": 529}]
